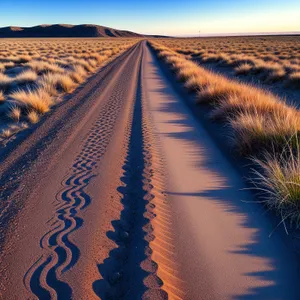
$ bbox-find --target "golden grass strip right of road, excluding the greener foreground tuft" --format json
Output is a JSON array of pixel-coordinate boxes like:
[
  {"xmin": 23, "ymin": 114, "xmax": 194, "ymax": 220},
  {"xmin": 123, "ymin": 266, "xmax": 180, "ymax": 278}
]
[{"xmin": 152, "ymin": 43, "xmax": 300, "ymax": 153}]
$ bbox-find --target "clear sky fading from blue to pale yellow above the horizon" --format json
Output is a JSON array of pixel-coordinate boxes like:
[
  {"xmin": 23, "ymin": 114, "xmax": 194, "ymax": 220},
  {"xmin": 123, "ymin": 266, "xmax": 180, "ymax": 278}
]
[{"xmin": 0, "ymin": 0, "xmax": 300, "ymax": 35}]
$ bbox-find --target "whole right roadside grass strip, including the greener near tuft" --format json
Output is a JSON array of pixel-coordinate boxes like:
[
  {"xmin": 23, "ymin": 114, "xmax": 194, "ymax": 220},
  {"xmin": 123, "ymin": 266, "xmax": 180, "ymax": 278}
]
[{"xmin": 151, "ymin": 41, "xmax": 300, "ymax": 226}]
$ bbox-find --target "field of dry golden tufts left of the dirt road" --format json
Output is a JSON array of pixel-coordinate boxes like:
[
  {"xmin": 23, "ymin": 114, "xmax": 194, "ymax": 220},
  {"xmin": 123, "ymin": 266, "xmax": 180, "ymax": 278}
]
[{"xmin": 0, "ymin": 38, "xmax": 137, "ymax": 140}]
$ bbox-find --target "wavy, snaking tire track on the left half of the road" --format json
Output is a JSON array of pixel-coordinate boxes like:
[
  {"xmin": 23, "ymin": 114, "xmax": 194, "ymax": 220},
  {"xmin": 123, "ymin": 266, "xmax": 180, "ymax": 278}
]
[{"xmin": 24, "ymin": 43, "xmax": 143, "ymax": 299}]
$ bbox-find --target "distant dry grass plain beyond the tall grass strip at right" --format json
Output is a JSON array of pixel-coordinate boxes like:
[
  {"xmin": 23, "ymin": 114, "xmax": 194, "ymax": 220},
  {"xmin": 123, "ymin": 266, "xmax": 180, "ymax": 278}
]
[{"xmin": 154, "ymin": 36, "xmax": 300, "ymax": 89}]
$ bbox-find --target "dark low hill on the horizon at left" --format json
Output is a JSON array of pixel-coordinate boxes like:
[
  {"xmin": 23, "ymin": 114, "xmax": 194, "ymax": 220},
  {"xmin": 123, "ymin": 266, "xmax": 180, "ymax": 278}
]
[{"xmin": 0, "ymin": 24, "xmax": 143, "ymax": 38}]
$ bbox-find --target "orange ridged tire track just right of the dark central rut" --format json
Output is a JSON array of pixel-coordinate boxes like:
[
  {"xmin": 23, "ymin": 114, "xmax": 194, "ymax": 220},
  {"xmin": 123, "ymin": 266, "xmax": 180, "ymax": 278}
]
[{"xmin": 141, "ymin": 50, "xmax": 186, "ymax": 300}]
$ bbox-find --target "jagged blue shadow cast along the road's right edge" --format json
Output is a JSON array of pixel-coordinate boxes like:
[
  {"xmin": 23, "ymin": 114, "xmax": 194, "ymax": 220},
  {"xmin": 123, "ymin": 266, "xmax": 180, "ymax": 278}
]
[{"xmin": 149, "ymin": 56, "xmax": 299, "ymax": 300}]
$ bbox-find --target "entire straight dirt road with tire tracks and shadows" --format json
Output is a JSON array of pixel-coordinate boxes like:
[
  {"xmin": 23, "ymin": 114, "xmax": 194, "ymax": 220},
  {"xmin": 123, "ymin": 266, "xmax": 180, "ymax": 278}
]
[{"xmin": 0, "ymin": 41, "xmax": 299, "ymax": 300}]
